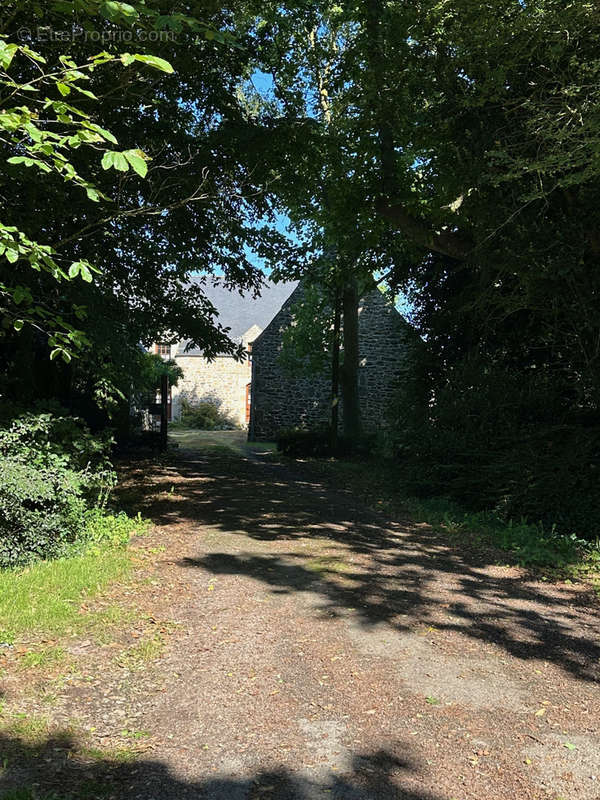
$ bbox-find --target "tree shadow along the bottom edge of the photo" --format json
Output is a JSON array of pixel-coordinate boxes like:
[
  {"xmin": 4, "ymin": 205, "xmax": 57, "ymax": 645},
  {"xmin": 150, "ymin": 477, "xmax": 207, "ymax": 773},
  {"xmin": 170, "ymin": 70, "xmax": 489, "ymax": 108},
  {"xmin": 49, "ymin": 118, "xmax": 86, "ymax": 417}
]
[{"xmin": 0, "ymin": 732, "xmax": 441, "ymax": 800}]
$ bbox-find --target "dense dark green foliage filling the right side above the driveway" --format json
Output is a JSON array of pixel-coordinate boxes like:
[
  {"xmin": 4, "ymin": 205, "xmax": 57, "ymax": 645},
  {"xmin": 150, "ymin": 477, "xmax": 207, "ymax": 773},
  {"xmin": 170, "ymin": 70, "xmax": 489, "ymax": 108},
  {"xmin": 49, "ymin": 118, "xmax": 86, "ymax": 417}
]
[{"xmin": 240, "ymin": 0, "xmax": 600, "ymax": 536}]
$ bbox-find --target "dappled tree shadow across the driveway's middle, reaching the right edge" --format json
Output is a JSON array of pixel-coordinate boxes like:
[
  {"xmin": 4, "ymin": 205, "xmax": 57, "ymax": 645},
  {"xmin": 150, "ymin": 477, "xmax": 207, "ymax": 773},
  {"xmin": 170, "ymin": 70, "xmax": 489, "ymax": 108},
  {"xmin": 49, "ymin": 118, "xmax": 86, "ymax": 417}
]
[{"xmin": 116, "ymin": 446, "xmax": 600, "ymax": 681}]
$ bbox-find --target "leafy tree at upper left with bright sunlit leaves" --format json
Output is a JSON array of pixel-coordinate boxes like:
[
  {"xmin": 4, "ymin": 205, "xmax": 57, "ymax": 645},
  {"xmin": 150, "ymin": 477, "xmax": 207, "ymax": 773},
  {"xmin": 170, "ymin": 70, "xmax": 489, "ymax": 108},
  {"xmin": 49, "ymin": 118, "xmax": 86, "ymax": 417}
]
[{"xmin": 0, "ymin": 0, "xmax": 296, "ymax": 418}]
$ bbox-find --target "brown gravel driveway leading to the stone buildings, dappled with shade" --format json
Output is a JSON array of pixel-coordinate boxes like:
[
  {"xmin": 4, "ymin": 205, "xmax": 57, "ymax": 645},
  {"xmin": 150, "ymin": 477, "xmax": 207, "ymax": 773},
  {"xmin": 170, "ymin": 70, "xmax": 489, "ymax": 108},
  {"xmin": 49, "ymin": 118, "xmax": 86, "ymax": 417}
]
[{"xmin": 0, "ymin": 452, "xmax": 600, "ymax": 800}]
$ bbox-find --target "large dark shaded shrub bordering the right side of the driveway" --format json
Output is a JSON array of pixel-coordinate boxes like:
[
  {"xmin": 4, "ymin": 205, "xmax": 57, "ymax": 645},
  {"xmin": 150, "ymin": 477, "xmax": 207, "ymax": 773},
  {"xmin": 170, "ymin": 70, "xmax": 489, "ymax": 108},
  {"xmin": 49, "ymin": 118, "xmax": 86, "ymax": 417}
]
[{"xmin": 395, "ymin": 358, "xmax": 600, "ymax": 539}]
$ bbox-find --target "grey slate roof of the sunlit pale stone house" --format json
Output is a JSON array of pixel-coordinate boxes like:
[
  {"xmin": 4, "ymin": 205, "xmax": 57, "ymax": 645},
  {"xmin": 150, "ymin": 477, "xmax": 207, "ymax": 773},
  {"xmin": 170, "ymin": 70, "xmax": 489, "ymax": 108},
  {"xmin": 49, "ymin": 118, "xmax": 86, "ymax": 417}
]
[{"xmin": 177, "ymin": 278, "xmax": 297, "ymax": 356}]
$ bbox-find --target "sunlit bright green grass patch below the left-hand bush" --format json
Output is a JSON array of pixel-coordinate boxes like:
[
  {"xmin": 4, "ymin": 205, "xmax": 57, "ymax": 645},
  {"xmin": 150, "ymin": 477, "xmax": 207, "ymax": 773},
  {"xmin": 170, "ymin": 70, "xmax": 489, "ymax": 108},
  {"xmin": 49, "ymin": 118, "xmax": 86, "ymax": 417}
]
[{"xmin": 0, "ymin": 548, "xmax": 130, "ymax": 641}]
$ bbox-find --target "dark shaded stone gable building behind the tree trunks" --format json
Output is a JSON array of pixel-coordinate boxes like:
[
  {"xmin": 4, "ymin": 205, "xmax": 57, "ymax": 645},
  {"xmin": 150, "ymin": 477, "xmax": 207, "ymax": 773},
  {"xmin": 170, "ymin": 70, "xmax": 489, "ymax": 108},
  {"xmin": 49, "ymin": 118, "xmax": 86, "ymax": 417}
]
[{"xmin": 249, "ymin": 285, "xmax": 417, "ymax": 441}]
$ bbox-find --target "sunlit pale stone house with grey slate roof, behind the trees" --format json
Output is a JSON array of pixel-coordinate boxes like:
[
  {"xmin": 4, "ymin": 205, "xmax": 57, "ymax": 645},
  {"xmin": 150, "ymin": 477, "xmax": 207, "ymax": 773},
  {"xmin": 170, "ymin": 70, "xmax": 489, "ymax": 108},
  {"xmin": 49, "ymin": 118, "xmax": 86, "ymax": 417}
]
[{"xmin": 151, "ymin": 281, "xmax": 296, "ymax": 427}]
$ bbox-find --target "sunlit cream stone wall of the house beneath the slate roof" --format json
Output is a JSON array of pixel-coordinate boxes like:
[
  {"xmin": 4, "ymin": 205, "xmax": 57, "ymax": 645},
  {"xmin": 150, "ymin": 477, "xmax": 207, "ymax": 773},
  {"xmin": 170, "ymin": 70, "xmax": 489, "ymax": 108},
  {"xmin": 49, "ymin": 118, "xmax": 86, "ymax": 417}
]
[{"xmin": 173, "ymin": 355, "xmax": 251, "ymax": 427}]
